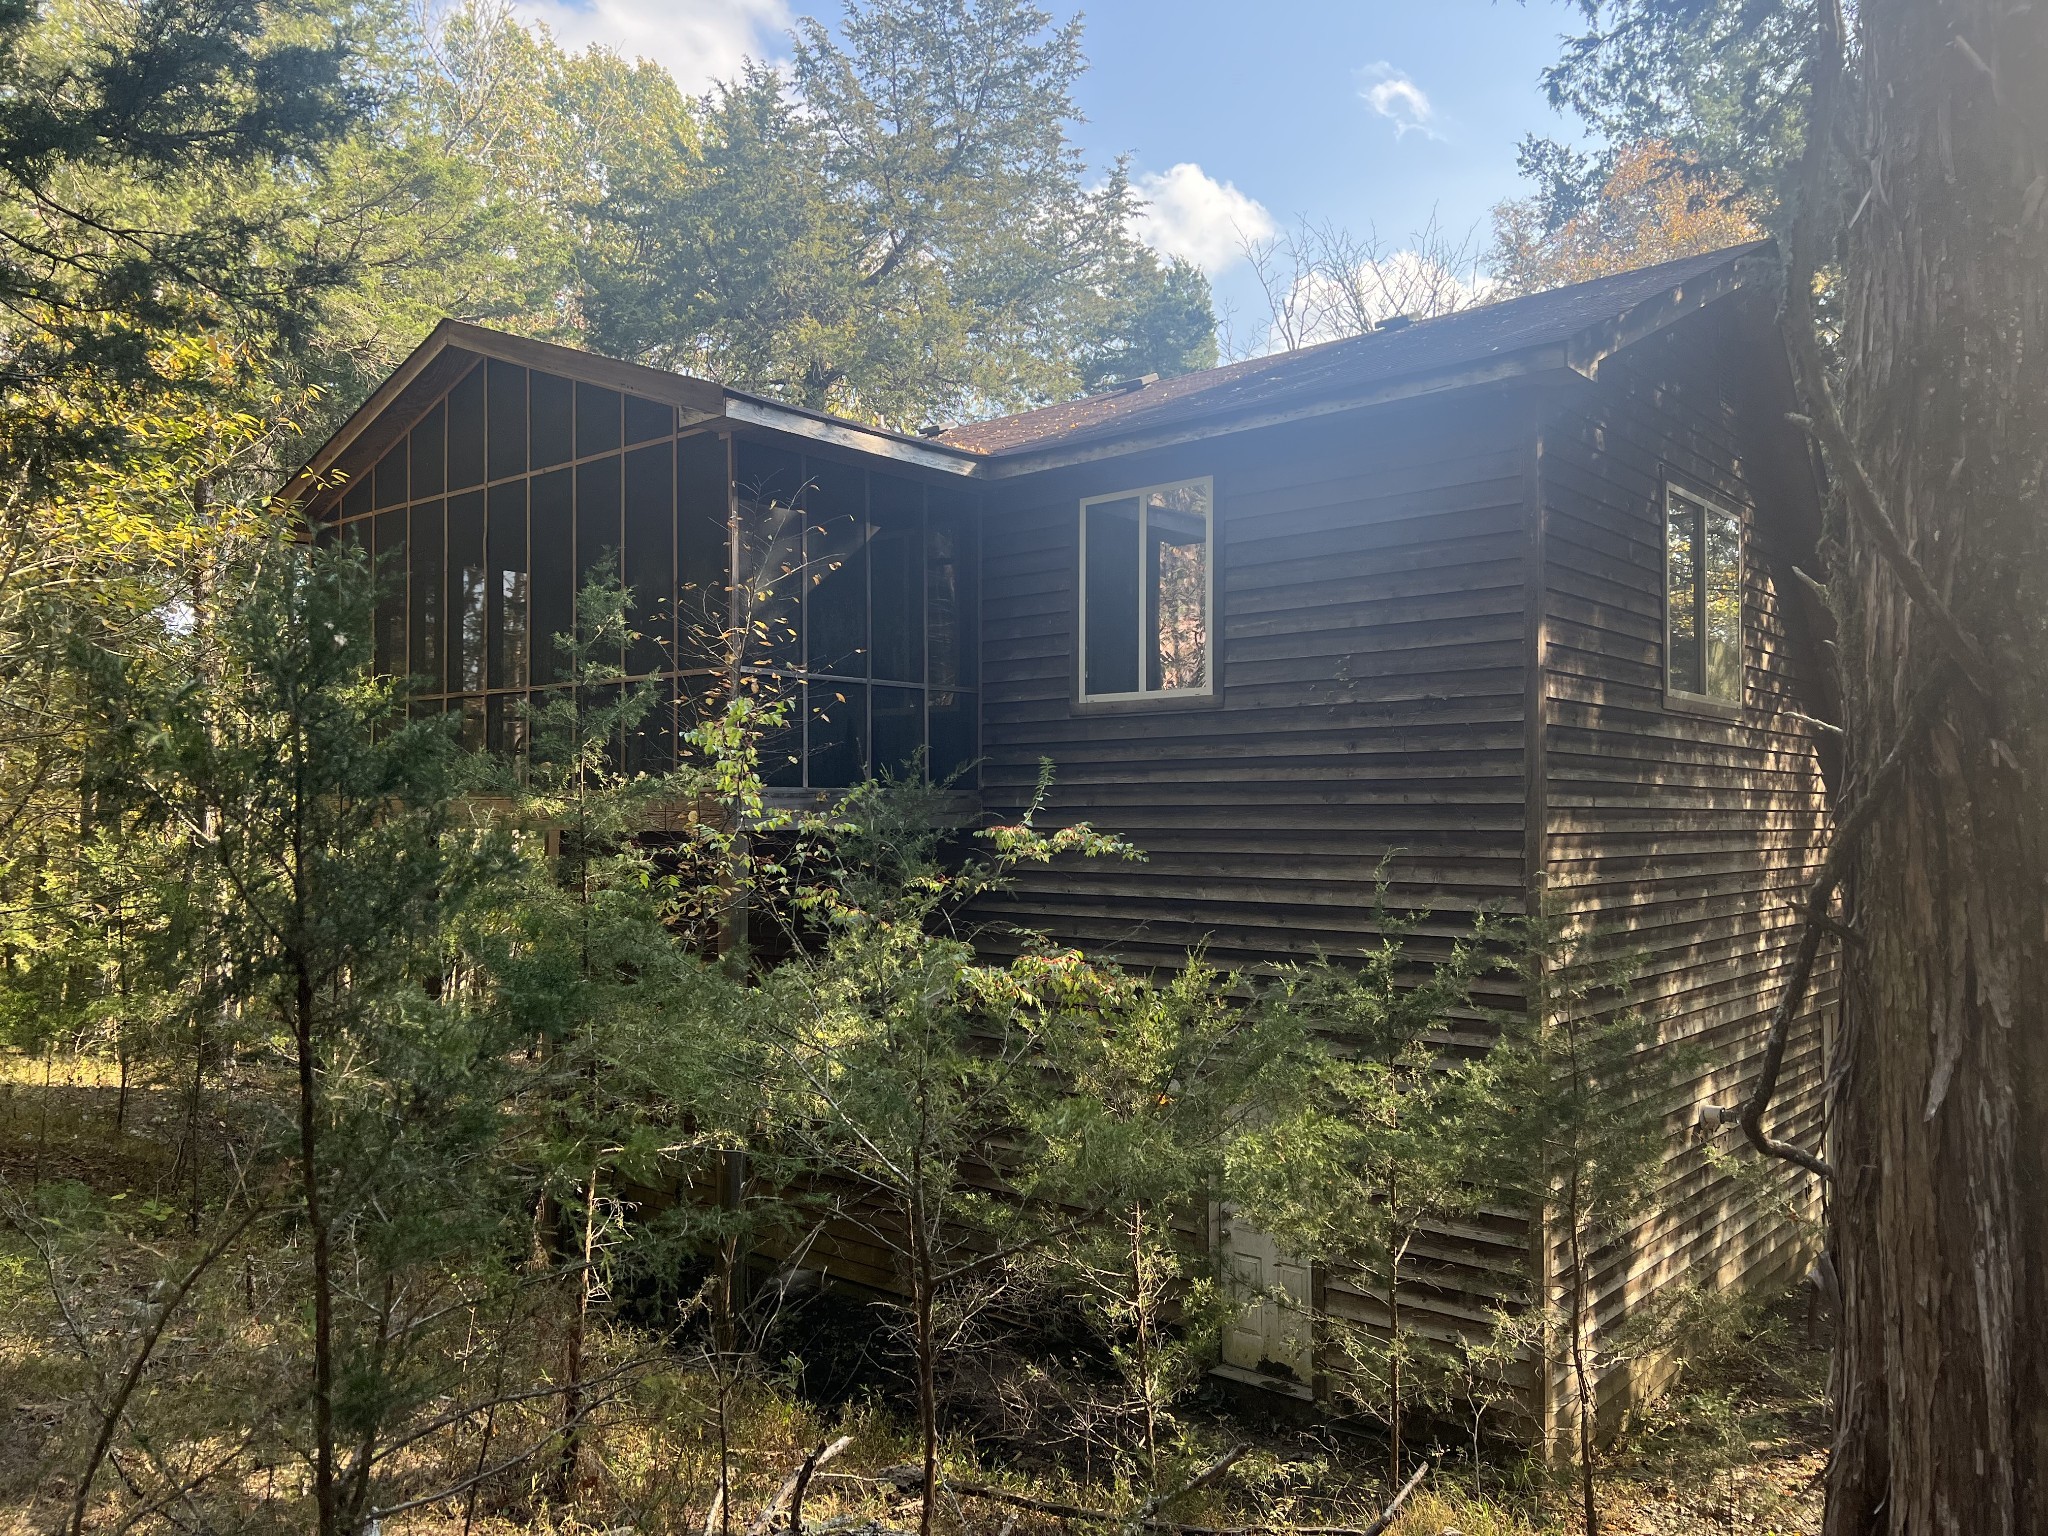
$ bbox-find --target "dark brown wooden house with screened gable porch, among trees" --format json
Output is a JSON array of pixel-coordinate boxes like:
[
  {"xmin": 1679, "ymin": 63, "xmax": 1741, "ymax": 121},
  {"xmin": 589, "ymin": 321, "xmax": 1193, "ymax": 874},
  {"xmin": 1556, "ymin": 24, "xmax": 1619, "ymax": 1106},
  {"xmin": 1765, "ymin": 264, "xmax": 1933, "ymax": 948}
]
[{"xmin": 280, "ymin": 248, "xmax": 1837, "ymax": 1427}]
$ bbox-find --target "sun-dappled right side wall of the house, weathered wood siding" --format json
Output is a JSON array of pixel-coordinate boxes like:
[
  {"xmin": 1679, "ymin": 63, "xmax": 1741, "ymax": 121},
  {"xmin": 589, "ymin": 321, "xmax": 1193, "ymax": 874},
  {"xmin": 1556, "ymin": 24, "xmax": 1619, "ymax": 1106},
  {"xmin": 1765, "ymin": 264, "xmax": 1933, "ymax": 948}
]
[{"xmin": 1542, "ymin": 324, "xmax": 1837, "ymax": 1433}]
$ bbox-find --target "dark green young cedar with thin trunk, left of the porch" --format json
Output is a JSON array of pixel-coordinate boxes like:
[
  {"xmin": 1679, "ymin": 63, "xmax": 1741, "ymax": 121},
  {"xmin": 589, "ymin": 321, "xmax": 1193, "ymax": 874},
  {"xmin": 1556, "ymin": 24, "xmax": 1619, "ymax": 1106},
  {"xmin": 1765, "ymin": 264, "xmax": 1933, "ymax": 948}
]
[{"xmin": 96, "ymin": 541, "xmax": 536, "ymax": 1536}]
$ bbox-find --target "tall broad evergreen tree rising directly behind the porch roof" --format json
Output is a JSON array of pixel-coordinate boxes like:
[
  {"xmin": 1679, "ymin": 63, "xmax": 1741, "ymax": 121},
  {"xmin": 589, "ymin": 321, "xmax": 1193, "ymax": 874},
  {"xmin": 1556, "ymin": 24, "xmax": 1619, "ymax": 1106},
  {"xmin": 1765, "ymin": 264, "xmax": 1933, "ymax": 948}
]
[{"xmin": 584, "ymin": 0, "xmax": 1214, "ymax": 428}]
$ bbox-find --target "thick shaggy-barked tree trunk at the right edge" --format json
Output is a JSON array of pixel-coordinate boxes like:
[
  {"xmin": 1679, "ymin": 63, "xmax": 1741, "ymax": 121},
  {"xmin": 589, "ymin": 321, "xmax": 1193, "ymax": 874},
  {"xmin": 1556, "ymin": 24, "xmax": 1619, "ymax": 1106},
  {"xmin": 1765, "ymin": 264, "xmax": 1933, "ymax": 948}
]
[{"xmin": 1827, "ymin": 0, "xmax": 2048, "ymax": 1536}]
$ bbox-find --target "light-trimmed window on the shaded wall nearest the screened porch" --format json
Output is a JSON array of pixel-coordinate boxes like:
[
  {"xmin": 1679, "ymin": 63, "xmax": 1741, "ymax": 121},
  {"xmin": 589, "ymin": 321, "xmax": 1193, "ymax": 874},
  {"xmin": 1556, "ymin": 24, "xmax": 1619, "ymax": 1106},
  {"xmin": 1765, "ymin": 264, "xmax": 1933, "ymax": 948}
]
[{"xmin": 1081, "ymin": 477, "xmax": 1217, "ymax": 700}]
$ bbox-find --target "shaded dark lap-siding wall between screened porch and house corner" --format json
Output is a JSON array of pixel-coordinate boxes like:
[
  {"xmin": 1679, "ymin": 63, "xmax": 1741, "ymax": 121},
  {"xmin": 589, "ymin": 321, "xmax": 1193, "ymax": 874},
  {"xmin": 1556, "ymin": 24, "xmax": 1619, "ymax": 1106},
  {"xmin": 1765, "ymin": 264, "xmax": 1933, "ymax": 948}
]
[{"xmin": 981, "ymin": 401, "xmax": 1526, "ymax": 999}]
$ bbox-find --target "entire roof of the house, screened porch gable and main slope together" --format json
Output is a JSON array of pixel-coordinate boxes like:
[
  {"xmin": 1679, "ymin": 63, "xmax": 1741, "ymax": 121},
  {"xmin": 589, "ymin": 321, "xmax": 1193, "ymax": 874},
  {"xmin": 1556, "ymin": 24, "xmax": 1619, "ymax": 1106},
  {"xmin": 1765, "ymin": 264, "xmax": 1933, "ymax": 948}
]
[{"xmin": 281, "ymin": 242, "xmax": 1774, "ymax": 500}]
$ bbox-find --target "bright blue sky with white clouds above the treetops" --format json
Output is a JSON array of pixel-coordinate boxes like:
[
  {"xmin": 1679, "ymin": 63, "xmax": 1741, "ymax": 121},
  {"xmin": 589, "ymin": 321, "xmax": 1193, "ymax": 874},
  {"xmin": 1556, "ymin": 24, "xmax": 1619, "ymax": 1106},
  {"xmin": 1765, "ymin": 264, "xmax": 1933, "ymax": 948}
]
[{"xmin": 516, "ymin": 0, "xmax": 1575, "ymax": 327}]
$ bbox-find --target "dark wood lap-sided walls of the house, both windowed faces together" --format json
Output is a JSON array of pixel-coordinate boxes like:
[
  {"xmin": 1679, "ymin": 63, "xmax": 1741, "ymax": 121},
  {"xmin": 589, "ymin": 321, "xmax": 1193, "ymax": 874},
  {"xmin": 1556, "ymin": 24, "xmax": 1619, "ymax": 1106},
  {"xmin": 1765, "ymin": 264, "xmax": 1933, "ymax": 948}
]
[{"xmin": 983, "ymin": 311, "xmax": 1835, "ymax": 1423}]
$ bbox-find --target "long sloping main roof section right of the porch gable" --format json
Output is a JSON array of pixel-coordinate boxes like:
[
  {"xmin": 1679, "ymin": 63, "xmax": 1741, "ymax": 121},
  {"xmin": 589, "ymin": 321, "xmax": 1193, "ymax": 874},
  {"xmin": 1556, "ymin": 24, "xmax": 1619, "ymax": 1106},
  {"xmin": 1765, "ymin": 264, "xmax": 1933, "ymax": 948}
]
[{"xmin": 938, "ymin": 242, "xmax": 1769, "ymax": 457}]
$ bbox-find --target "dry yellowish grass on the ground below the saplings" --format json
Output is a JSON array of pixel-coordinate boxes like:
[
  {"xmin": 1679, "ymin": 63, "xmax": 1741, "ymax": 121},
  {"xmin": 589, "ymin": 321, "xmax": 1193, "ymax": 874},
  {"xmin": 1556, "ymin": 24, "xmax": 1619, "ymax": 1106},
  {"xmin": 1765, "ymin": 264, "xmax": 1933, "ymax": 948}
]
[{"xmin": 0, "ymin": 1057, "xmax": 1825, "ymax": 1536}]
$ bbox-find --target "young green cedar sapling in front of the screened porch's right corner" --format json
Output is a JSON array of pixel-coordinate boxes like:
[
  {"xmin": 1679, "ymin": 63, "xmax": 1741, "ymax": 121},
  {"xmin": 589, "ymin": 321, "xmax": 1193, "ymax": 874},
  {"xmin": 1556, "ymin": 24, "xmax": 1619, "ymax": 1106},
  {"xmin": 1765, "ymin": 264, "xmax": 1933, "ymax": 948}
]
[{"xmin": 760, "ymin": 778, "xmax": 1130, "ymax": 1536}]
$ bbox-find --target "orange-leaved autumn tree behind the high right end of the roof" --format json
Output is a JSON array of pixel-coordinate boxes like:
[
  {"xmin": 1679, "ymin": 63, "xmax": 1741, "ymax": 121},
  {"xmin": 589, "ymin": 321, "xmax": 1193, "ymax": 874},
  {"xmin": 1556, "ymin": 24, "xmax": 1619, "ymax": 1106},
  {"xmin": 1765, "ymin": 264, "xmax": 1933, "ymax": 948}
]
[{"xmin": 1491, "ymin": 141, "xmax": 1763, "ymax": 295}]
